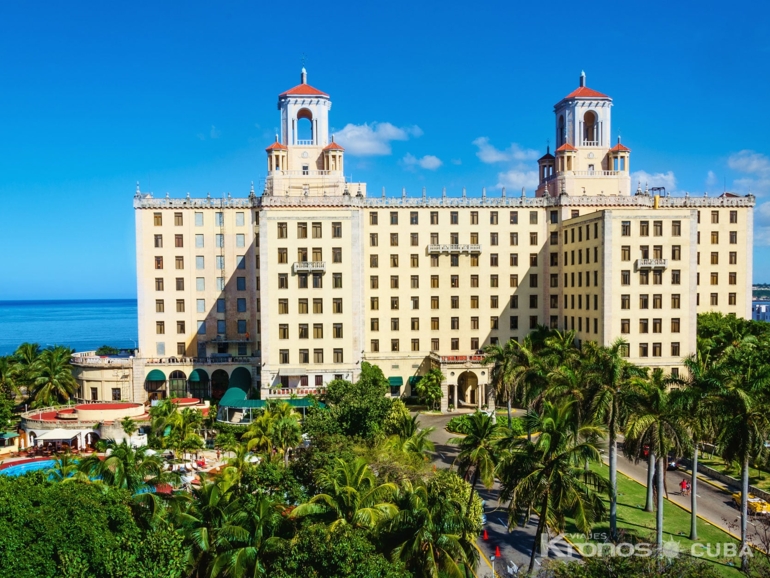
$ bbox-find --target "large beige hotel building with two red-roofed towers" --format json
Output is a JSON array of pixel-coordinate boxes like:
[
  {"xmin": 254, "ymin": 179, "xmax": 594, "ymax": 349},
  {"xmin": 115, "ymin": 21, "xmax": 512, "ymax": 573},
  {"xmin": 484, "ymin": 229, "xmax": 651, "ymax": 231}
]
[{"xmin": 115, "ymin": 72, "xmax": 754, "ymax": 408}]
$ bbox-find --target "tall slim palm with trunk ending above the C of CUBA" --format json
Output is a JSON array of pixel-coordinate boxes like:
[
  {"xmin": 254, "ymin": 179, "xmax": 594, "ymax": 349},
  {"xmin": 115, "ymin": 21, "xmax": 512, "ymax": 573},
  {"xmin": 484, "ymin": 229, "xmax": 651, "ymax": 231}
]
[{"xmin": 675, "ymin": 351, "xmax": 720, "ymax": 540}]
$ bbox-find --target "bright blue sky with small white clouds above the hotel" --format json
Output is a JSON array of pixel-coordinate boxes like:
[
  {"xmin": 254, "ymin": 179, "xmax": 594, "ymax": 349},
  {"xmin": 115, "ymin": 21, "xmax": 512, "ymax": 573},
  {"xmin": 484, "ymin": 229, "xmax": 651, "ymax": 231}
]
[{"xmin": 0, "ymin": 1, "xmax": 770, "ymax": 299}]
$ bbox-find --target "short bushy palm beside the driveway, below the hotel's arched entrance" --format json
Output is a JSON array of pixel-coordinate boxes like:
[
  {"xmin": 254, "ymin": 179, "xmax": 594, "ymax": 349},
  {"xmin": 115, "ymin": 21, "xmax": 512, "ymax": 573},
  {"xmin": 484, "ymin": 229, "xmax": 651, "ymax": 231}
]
[{"xmin": 449, "ymin": 411, "xmax": 503, "ymax": 507}]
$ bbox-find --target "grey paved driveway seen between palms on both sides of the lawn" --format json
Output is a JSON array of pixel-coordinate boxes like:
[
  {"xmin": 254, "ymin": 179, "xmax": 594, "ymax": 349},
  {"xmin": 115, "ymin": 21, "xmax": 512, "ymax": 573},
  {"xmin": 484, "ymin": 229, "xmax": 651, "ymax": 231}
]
[{"xmin": 420, "ymin": 410, "xmax": 755, "ymax": 578}]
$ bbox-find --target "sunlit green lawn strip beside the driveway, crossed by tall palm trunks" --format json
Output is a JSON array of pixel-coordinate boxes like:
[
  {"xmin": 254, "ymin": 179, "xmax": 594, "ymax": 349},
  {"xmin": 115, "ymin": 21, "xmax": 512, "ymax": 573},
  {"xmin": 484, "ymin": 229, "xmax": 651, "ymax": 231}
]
[{"xmin": 566, "ymin": 464, "xmax": 742, "ymax": 578}]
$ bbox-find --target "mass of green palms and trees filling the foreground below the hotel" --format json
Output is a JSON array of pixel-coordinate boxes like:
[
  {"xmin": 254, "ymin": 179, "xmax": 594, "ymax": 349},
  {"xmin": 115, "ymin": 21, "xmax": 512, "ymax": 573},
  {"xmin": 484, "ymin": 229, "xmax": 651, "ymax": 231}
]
[{"xmin": 0, "ymin": 314, "xmax": 770, "ymax": 578}]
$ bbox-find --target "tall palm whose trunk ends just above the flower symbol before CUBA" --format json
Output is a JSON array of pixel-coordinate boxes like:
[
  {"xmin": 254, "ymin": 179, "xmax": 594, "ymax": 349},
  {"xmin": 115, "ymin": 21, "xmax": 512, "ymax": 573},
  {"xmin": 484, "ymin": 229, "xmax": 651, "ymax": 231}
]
[{"xmin": 626, "ymin": 368, "xmax": 689, "ymax": 553}]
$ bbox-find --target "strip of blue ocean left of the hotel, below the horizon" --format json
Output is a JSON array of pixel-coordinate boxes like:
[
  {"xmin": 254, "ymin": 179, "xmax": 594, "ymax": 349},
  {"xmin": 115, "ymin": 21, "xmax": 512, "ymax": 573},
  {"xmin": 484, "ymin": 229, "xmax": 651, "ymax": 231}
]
[{"xmin": 0, "ymin": 299, "xmax": 138, "ymax": 355}]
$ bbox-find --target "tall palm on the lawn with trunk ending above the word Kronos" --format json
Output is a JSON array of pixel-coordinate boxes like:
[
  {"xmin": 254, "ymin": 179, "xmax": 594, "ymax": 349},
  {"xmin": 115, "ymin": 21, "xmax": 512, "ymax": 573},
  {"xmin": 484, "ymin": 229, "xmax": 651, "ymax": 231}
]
[{"xmin": 584, "ymin": 339, "xmax": 640, "ymax": 540}]
